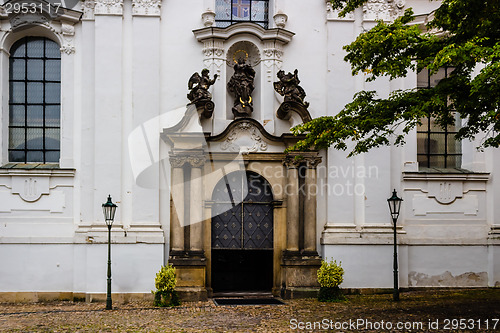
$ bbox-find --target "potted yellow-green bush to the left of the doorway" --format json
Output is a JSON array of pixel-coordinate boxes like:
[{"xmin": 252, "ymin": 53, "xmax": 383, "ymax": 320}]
[{"xmin": 151, "ymin": 264, "xmax": 181, "ymax": 306}]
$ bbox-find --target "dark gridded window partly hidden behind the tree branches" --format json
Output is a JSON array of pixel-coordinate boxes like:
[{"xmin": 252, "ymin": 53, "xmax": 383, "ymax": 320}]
[{"xmin": 417, "ymin": 67, "xmax": 462, "ymax": 168}]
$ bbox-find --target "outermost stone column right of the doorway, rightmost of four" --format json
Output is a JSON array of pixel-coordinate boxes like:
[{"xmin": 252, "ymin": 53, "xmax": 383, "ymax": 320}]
[{"xmin": 304, "ymin": 156, "xmax": 321, "ymax": 255}]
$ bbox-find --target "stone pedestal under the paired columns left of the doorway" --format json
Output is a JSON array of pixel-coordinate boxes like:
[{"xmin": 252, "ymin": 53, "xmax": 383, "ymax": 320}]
[{"xmin": 168, "ymin": 251, "xmax": 208, "ymax": 301}]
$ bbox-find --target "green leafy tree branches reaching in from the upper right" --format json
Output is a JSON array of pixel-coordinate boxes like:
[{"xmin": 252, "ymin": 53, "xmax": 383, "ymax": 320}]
[{"xmin": 290, "ymin": 0, "xmax": 500, "ymax": 156}]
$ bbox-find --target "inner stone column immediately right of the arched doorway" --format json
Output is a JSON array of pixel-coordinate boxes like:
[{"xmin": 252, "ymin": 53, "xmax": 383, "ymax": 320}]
[{"xmin": 283, "ymin": 155, "xmax": 300, "ymax": 252}]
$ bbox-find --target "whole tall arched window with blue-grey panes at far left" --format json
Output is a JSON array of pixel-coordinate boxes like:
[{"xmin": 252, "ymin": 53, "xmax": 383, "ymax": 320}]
[{"xmin": 9, "ymin": 37, "xmax": 61, "ymax": 163}]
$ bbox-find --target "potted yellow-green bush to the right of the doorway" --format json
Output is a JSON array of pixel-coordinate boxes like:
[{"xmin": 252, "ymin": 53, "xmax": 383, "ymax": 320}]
[{"xmin": 318, "ymin": 260, "xmax": 345, "ymax": 302}]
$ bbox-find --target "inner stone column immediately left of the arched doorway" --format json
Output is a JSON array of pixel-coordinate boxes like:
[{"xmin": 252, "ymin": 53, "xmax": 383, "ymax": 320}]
[{"xmin": 187, "ymin": 155, "xmax": 206, "ymax": 253}]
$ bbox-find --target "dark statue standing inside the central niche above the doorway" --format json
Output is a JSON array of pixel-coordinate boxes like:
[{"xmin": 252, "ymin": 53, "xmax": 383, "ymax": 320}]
[{"xmin": 227, "ymin": 57, "xmax": 255, "ymax": 118}]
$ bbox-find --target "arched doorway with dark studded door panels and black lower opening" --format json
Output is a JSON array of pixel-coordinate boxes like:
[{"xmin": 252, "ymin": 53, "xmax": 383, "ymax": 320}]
[{"xmin": 211, "ymin": 171, "xmax": 274, "ymax": 292}]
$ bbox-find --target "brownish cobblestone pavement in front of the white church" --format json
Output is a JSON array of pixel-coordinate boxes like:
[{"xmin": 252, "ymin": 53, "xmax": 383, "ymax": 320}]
[{"xmin": 0, "ymin": 288, "xmax": 500, "ymax": 333}]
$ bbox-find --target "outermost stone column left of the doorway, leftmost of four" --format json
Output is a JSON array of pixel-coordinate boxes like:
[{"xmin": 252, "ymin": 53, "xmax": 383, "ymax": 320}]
[{"xmin": 170, "ymin": 155, "xmax": 186, "ymax": 252}]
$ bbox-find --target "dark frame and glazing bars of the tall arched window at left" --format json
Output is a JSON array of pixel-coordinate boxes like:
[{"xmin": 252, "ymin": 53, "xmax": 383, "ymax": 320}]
[{"xmin": 7, "ymin": 36, "xmax": 62, "ymax": 164}]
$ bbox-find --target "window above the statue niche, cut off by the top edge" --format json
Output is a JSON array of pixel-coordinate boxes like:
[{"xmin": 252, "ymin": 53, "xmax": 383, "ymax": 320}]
[{"xmin": 215, "ymin": 0, "xmax": 269, "ymax": 29}]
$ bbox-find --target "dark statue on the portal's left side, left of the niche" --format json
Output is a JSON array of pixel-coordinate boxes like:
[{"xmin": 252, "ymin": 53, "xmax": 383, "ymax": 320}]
[{"xmin": 187, "ymin": 68, "xmax": 218, "ymax": 118}]
